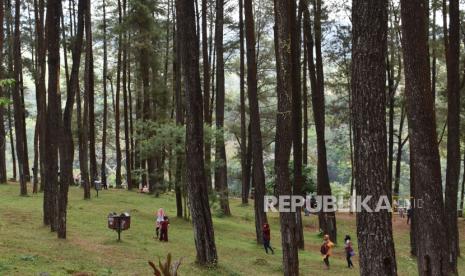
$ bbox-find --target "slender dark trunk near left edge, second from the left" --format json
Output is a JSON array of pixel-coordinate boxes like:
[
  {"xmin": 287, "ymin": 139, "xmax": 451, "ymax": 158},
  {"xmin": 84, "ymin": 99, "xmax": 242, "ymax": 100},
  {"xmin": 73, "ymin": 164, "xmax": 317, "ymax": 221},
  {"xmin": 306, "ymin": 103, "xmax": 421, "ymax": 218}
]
[{"xmin": 13, "ymin": 0, "xmax": 29, "ymax": 196}]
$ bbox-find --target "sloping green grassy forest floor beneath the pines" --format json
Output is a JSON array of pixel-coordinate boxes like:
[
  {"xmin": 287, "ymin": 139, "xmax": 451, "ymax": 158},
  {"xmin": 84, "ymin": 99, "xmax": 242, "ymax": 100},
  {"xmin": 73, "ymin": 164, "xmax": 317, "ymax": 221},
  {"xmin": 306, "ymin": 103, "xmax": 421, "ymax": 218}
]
[{"xmin": 0, "ymin": 184, "xmax": 465, "ymax": 276}]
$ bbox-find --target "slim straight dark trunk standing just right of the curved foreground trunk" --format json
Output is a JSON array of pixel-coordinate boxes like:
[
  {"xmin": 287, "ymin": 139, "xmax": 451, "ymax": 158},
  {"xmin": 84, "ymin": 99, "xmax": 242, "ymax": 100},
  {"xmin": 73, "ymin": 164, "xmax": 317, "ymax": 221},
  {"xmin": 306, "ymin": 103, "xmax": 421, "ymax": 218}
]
[{"xmin": 215, "ymin": 0, "xmax": 231, "ymax": 216}]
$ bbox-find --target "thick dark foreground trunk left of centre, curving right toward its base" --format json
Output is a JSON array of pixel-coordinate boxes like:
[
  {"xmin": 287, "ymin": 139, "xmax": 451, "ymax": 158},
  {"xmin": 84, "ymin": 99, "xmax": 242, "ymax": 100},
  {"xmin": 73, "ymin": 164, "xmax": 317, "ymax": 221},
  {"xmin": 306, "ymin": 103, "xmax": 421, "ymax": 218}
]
[{"xmin": 176, "ymin": 0, "xmax": 218, "ymax": 265}]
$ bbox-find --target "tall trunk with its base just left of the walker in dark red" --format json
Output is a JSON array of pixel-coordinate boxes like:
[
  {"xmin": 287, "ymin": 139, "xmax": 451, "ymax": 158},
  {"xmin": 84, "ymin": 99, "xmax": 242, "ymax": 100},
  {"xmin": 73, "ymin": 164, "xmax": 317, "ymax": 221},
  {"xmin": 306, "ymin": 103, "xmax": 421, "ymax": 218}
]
[{"xmin": 244, "ymin": 0, "xmax": 268, "ymax": 244}]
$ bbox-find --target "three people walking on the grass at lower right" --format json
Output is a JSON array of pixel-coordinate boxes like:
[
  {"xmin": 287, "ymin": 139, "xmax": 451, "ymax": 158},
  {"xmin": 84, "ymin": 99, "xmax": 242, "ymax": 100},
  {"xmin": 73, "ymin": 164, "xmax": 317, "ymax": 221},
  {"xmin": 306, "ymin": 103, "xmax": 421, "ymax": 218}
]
[{"xmin": 262, "ymin": 223, "xmax": 355, "ymax": 269}]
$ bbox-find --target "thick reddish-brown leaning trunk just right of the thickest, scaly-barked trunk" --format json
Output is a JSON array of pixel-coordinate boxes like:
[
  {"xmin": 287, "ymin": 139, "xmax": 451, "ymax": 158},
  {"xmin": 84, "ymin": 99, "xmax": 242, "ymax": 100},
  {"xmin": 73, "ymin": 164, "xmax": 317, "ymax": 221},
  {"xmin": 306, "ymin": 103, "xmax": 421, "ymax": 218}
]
[{"xmin": 401, "ymin": 0, "xmax": 448, "ymax": 275}]
